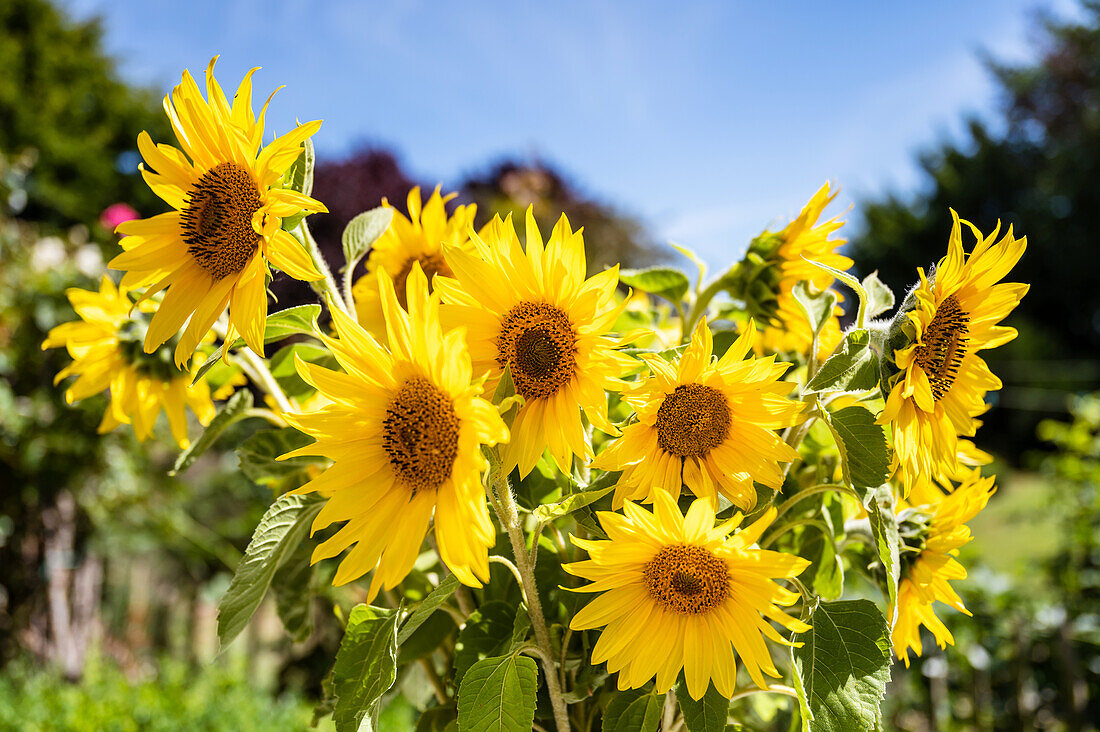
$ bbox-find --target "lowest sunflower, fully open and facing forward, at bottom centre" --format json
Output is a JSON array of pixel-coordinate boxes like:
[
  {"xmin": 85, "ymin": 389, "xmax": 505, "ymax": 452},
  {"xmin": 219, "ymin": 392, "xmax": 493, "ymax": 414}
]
[{"xmin": 563, "ymin": 491, "xmax": 810, "ymax": 699}]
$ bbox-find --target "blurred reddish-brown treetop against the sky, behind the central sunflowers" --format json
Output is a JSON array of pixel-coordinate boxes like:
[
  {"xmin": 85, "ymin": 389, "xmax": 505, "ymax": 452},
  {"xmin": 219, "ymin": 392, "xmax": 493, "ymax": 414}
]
[{"xmin": 461, "ymin": 160, "xmax": 667, "ymax": 275}]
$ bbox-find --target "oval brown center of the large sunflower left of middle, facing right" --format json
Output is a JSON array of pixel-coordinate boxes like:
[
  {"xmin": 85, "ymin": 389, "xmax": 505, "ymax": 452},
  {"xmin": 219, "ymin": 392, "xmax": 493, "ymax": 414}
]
[{"xmin": 382, "ymin": 376, "xmax": 459, "ymax": 494}]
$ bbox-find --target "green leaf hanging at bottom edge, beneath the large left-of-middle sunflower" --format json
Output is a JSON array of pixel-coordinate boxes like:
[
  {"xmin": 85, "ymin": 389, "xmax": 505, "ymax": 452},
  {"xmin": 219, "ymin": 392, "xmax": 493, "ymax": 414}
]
[{"xmin": 332, "ymin": 604, "xmax": 398, "ymax": 732}]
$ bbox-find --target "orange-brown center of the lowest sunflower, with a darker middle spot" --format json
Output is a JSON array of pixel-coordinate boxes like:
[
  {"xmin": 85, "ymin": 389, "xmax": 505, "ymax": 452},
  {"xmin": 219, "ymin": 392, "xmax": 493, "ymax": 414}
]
[{"xmin": 644, "ymin": 544, "xmax": 729, "ymax": 615}]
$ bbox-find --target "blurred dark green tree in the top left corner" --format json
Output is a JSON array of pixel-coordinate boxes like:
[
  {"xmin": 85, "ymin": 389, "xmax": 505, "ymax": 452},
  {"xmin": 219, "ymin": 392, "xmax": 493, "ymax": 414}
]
[{"xmin": 0, "ymin": 0, "xmax": 171, "ymax": 227}]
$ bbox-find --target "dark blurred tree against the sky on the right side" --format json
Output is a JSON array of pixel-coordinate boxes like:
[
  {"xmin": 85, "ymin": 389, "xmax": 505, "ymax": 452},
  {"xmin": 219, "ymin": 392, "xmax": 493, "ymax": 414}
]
[{"xmin": 849, "ymin": 2, "xmax": 1100, "ymax": 456}]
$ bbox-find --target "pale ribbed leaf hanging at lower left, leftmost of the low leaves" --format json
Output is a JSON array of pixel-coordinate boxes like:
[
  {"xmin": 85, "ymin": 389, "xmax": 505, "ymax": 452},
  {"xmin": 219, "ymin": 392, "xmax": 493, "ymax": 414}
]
[{"xmin": 218, "ymin": 493, "xmax": 325, "ymax": 648}]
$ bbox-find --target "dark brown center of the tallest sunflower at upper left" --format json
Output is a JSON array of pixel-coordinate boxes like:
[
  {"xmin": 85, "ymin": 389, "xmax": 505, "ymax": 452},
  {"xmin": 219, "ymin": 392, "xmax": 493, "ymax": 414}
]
[{"xmin": 179, "ymin": 163, "xmax": 263, "ymax": 280}]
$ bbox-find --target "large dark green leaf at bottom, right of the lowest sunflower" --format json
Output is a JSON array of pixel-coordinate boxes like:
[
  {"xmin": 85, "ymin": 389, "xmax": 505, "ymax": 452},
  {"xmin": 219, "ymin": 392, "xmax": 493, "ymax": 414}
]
[{"xmin": 791, "ymin": 600, "xmax": 890, "ymax": 732}]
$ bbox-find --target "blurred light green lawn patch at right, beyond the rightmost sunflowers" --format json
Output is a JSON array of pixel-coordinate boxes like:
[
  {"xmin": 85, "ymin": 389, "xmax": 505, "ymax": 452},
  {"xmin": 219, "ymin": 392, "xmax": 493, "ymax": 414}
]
[{"xmin": 963, "ymin": 472, "xmax": 1060, "ymax": 594}]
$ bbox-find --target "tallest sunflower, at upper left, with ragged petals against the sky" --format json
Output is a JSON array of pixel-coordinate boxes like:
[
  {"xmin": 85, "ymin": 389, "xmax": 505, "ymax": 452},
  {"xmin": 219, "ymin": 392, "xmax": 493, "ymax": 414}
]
[{"xmin": 109, "ymin": 57, "xmax": 327, "ymax": 363}]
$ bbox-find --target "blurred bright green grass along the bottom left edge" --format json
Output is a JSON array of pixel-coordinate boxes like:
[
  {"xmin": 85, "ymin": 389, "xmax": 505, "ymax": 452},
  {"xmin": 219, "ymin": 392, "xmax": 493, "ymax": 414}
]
[{"xmin": 0, "ymin": 656, "xmax": 331, "ymax": 732}]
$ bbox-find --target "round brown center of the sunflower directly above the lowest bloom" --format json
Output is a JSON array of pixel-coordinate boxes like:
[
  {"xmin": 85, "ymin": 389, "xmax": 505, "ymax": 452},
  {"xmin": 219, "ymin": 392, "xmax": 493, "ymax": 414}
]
[{"xmin": 657, "ymin": 384, "xmax": 729, "ymax": 458}]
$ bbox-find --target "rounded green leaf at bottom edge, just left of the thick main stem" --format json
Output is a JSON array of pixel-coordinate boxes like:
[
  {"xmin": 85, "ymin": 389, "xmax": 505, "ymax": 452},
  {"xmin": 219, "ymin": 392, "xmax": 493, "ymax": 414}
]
[{"xmin": 459, "ymin": 655, "xmax": 538, "ymax": 732}]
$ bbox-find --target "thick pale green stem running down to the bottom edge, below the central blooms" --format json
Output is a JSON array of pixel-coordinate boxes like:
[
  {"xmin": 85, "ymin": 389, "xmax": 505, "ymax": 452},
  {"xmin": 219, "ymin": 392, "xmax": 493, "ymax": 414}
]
[{"xmin": 490, "ymin": 452, "xmax": 570, "ymax": 732}]
